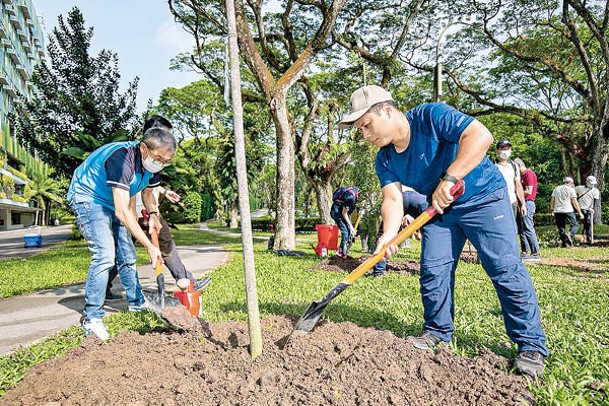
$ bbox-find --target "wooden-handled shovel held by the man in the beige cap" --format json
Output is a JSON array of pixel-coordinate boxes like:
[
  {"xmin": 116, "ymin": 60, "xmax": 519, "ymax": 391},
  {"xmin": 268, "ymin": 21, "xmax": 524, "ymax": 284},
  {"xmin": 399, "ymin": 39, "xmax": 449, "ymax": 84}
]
[{"xmin": 292, "ymin": 180, "xmax": 465, "ymax": 336}]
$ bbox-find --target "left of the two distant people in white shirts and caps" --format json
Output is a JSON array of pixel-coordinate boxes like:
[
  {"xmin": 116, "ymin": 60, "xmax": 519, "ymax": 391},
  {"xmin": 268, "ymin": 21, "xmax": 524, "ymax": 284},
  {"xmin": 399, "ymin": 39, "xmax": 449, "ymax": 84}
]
[{"xmin": 550, "ymin": 176, "xmax": 584, "ymax": 248}]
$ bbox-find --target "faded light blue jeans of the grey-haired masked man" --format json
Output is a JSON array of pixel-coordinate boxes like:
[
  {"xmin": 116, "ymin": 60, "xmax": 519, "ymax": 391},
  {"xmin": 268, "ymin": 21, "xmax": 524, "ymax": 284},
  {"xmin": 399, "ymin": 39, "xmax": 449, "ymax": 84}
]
[{"xmin": 70, "ymin": 200, "xmax": 144, "ymax": 321}]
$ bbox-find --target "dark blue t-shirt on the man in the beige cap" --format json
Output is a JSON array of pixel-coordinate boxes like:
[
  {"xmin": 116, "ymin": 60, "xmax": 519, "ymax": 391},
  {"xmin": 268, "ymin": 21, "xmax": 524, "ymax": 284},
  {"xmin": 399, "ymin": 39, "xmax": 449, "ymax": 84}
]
[{"xmin": 376, "ymin": 103, "xmax": 505, "ymax": 205}]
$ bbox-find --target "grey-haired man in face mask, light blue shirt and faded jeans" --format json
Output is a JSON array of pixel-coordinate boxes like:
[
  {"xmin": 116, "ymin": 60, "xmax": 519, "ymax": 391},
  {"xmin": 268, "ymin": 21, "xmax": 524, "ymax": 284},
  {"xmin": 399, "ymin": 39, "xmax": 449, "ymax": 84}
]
[{"xmin": 67, "ymin": 127, "xmax": 176, "ymax": 340}]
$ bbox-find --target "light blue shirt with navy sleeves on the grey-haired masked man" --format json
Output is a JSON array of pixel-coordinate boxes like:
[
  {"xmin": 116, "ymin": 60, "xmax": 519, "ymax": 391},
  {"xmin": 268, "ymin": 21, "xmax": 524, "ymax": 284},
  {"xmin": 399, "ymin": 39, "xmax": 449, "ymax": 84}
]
[{"xmin": 67, "ymin": 141, "xmax": 159, "ymax": 210}]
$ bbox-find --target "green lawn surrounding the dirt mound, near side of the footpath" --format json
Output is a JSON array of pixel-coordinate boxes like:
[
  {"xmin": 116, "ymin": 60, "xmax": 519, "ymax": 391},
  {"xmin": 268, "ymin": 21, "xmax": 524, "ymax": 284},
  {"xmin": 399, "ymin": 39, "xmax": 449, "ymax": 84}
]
[{"xmin": 0, "ymin": 229, "xmax": 609, "ymax": 405}]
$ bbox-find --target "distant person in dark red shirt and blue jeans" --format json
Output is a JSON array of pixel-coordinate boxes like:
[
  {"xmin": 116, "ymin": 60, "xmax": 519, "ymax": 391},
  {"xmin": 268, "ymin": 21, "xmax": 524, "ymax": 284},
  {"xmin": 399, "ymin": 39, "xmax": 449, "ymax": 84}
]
[{"xmin": 514, "ymin": 158, "xmax": 539, "ymax": 261}]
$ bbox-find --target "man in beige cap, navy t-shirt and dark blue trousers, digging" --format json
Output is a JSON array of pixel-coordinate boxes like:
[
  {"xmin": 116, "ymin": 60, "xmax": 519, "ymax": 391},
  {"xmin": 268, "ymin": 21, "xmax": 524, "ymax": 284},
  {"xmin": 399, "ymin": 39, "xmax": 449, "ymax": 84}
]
[{"xmin": 340, "ymin": 85, "xmax": 548, "ymax": 377}]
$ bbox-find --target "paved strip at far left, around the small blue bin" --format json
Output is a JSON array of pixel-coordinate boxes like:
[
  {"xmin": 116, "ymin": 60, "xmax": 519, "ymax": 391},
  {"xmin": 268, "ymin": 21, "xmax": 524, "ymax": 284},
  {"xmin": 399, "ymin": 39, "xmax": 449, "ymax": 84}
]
[{"xmin": 0, "ymin": 225, "xmax": 72, "ymax": 259}]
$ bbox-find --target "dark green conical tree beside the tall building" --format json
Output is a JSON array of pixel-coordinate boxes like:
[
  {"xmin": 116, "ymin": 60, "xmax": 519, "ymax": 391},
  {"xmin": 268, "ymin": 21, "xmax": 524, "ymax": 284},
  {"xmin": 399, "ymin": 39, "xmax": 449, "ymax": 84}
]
[{"xmin": 13, "ymin": 7, "xmax": 138, "ymax": 176}]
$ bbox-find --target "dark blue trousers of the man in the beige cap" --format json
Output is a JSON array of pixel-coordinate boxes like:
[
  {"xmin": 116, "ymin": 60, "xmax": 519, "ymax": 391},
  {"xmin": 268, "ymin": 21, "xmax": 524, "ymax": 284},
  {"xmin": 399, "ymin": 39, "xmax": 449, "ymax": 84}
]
[{"xmin": 420, "ymin": 188, "xmax": 548, "ymax": 356}]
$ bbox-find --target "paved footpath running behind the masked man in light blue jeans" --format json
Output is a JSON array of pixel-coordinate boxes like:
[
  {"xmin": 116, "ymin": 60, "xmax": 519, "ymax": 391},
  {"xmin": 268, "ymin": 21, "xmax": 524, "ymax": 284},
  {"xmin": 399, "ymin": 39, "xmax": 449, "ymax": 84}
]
[{"xmin": 0, "ymin": 244, "xmax": 228, "ymax": 355}]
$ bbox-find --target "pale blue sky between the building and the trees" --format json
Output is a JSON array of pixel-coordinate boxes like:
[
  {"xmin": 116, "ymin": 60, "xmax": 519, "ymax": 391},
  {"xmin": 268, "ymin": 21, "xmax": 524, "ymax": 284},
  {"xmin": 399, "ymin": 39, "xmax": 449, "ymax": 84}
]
[{"xmin": 33, "ymin": 0, "xmax": 200, "ymax": 112}]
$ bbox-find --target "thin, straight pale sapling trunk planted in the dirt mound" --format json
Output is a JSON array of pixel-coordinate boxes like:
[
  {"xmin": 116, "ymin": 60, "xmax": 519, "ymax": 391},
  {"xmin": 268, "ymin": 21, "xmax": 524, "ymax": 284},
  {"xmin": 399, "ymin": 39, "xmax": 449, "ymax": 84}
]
[{"xmin": 226, "ymin": 0, "xmax": 262, "ymax": 358}]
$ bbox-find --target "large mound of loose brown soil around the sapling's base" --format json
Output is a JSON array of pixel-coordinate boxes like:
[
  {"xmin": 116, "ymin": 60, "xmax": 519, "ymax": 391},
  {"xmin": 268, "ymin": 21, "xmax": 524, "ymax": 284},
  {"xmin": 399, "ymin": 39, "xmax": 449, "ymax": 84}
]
[{"xmin": 0, "ymin": 317, "xmax": 532, "ymax": 405}]
